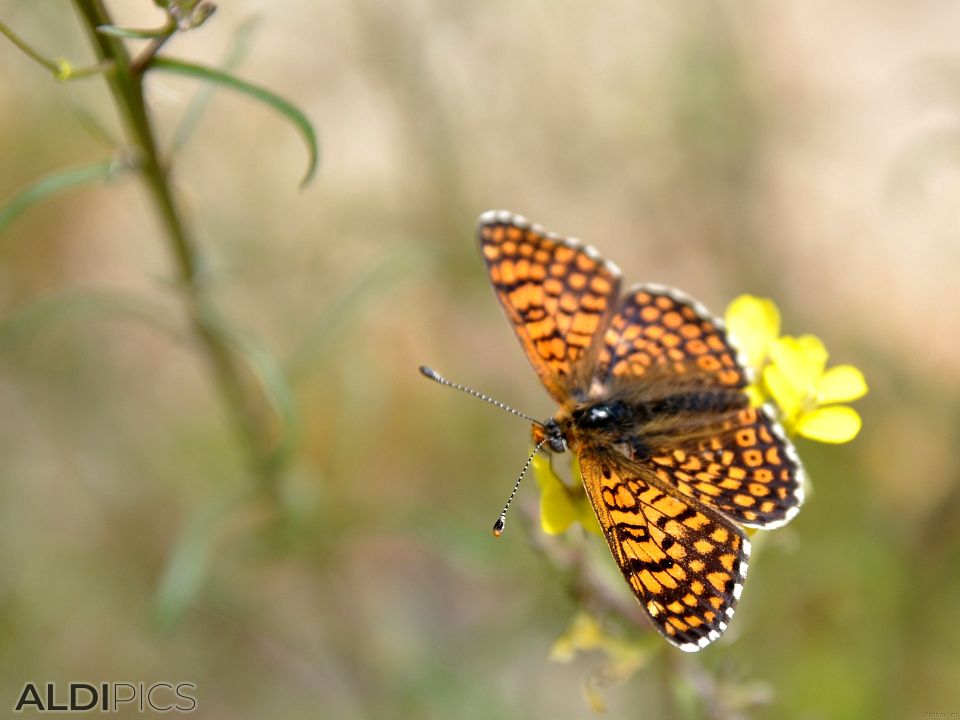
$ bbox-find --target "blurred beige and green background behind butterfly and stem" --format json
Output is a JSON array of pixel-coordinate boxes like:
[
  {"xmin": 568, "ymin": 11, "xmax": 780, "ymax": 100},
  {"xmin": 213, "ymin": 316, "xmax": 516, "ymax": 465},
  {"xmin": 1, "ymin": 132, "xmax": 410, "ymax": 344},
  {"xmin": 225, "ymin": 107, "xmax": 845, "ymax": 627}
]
[{"xmin": 0, "ymin": 0, "xmax": 960, "ymax": 720}]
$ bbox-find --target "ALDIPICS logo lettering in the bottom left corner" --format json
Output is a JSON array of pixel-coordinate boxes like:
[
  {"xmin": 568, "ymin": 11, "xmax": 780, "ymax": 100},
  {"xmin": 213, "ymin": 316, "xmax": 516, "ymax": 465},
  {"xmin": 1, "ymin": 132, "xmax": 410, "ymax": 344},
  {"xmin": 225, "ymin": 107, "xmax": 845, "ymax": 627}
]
[{"xmin": 13, "ymin": 682, "xmax": 197, "ymax": 713}]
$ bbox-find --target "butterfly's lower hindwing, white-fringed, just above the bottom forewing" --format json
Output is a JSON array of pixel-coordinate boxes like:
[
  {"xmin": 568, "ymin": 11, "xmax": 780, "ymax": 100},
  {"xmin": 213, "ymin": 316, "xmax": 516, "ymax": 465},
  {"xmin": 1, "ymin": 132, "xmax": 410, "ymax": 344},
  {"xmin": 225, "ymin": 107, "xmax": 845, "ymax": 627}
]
[{"xmin": 649, "ymin": 407, "xmax": 803, "ymax": 529}]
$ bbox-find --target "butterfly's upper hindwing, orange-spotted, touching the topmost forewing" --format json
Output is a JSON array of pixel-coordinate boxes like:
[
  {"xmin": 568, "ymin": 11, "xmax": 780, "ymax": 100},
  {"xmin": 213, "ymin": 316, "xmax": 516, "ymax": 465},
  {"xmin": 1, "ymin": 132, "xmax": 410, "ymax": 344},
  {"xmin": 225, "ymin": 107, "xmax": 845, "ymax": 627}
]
[{"xmin": 596, "ymin": 284, "xmax": 749, "ymax": 388}]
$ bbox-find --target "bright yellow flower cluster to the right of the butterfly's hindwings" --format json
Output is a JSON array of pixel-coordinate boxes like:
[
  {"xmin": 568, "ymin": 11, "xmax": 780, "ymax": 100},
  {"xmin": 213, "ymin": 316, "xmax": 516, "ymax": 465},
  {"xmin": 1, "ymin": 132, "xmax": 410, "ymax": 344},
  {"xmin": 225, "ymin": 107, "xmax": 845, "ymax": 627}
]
[{"xmin": 726, "ymin": 295, "xmax": 867, "ymax": 443}]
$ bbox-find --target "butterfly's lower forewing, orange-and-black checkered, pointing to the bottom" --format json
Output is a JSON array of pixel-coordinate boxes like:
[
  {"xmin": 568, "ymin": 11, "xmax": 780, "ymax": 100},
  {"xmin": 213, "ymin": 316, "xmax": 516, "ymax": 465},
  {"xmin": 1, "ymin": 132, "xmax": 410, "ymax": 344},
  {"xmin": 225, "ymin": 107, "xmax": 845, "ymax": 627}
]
[{"xmin": 579, "ymin": 445, "xmax": 750, "ymax": 652}]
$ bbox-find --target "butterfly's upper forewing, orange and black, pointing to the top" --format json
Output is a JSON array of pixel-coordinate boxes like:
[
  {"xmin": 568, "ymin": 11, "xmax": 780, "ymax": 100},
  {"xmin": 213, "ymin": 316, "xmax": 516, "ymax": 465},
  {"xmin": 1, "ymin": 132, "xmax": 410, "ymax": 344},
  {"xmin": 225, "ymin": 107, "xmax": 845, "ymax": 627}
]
[{"xmin": 477, "ymin": 211, "xmax": 620, "ymax": 403}]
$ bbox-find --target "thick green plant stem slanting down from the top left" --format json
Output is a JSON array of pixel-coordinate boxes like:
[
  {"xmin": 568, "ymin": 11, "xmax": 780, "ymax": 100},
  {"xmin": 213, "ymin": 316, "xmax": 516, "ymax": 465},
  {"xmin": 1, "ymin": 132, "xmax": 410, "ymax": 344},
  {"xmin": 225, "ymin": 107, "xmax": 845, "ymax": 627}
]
[{"xmin": 74, "ymin": 0, "xmax": 278, "ymax": 493}]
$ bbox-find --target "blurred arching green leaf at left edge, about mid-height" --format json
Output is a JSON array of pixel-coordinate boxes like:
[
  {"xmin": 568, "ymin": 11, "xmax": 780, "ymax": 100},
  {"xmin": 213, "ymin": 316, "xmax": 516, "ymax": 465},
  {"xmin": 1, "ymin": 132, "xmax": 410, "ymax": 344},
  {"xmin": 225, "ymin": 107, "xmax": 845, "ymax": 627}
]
[{"xmin": 0, "ymin": 289, "xmax": 185, "ymax": 348}]
